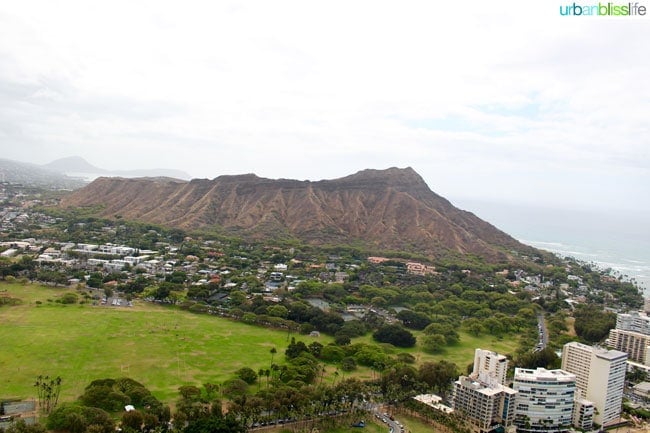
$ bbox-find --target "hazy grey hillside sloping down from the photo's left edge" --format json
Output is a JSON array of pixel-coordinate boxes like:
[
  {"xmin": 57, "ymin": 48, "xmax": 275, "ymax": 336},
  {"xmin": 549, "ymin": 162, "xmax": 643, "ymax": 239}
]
[{"xmin": 0, "ymin": 159, "xmax": 87, "ymax": 189}]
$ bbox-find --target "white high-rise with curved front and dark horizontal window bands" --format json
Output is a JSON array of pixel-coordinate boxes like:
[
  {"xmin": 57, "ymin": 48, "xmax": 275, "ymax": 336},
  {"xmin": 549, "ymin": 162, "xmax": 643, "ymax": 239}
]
[{"xmin": 512, "ymin": 368, "xmax": 576, "ymax": 433}]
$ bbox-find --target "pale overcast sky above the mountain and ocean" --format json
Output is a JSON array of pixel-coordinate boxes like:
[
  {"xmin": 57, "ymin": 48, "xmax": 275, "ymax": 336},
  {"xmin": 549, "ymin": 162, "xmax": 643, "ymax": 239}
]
[{"xmin": 0, "ymin": 0, "xmax": 650, "ymax": 210}]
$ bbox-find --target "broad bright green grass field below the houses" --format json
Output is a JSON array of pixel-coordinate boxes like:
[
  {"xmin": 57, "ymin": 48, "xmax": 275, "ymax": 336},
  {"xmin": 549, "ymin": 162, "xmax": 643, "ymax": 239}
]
[{"xmin": 0, "ymin": 283, "xmax": 516, "ymax": 403}]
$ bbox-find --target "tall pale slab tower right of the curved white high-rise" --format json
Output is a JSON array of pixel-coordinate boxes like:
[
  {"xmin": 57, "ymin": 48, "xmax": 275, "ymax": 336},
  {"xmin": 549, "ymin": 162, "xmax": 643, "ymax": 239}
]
[{"xmin": 562, "ymin": 342, "xmax": 628, "ymax": 426}]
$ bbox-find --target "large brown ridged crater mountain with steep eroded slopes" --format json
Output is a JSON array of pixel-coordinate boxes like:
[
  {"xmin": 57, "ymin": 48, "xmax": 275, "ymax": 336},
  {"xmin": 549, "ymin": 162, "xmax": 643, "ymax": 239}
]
[{"xmin": 62, "ymin": 168, "xmax": 536, "ymax": 261}]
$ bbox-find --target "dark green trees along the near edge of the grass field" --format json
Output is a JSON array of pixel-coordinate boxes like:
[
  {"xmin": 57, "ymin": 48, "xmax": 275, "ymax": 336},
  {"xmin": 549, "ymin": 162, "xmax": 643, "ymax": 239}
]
[{"xmin": 34, "ymin": 339, "xmax": 458, "ymax": 433}]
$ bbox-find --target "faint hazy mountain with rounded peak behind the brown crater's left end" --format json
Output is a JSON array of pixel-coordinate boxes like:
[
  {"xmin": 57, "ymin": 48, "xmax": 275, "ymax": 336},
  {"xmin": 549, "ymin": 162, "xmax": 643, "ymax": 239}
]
[{"xmin": 43, "ymin": 156, "xmax": 191, "ymax": 180}]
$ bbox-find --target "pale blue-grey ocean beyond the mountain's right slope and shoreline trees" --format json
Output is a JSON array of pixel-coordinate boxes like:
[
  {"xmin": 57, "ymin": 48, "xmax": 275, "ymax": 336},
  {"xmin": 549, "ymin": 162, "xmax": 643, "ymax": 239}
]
[{"xmin": 453, "ymin": 199, "xmax": 650, "ymax": 296}]
